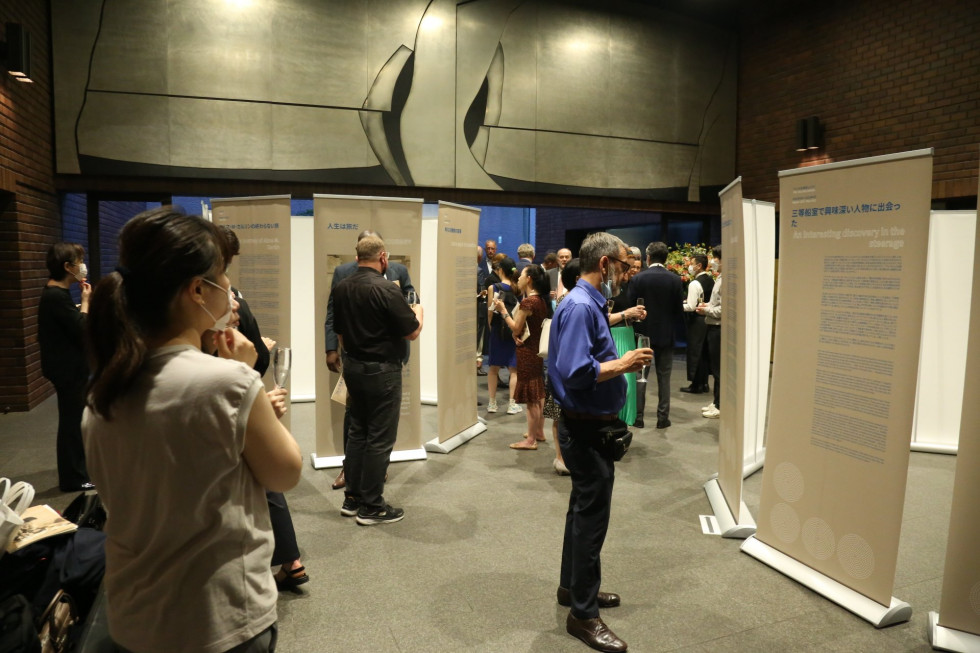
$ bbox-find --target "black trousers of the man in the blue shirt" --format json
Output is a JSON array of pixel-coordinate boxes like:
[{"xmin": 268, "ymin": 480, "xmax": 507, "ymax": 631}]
[{"xmin": 558, "ymin": 415, "xmax": 615, "ymax": 619}]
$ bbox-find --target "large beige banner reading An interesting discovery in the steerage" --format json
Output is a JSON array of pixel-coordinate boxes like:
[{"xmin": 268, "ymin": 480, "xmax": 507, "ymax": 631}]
[{"xmin": 742, "ymin": 150, "xmax": 932, "ymax": 627}]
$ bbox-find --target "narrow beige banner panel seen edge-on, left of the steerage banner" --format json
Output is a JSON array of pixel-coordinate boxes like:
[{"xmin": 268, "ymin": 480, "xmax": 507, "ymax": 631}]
[{"xmin": 718, "ymin": 177, "xmax": 749, "ymax": 522}]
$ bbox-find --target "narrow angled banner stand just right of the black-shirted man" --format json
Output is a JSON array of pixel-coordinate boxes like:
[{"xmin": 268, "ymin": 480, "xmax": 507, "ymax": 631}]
[{"xmin": 425, "ymin": 202, "xmax": 487, "ymax": 453}]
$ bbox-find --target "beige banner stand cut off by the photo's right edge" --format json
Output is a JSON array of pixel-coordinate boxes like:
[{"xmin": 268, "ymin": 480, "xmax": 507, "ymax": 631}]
[{"xmin": 929, "ymin": 158, "xmax": 980, "ymax": 653}]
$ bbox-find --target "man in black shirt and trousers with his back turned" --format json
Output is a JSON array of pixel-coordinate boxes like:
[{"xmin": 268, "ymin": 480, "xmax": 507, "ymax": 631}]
[{"xmin": 333, "ymin": 236, "xmax": 422, "ymax": 526}]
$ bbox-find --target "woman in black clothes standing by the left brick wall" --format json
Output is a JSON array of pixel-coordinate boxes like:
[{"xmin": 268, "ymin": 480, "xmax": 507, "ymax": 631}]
[{"xmin": 37, "ymin": 243, "xmax": 94, "ymax": 492}]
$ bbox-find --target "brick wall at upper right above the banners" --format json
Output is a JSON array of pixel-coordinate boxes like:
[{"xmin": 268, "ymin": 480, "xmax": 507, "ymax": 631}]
[{"xmin": 737, "ymin": 0, "xmax": 980, "ymax": 206}]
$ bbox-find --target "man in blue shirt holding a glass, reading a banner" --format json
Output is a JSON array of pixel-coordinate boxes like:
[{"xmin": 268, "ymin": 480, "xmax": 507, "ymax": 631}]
[{"xmin": 548, "ymin": 233, "xmax": 653, "ymax": 653}]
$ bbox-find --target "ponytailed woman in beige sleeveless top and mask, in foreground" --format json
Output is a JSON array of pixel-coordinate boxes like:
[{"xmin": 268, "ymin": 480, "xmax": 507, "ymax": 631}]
[{"xmin": 82, "ymin": 207, "xmax": 302, "ymax": 652}]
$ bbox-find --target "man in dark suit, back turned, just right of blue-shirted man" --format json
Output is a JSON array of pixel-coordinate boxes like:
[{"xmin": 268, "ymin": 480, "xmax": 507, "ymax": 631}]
[{"xmin": 629, "ymin": 242, "xmax": 684, "ymax": 429}]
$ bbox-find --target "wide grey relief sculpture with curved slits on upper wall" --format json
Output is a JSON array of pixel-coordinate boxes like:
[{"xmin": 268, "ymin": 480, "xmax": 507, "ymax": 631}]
[{"xmin": 51, "ymin": 0, "xmax": 735, "ymax": 200}]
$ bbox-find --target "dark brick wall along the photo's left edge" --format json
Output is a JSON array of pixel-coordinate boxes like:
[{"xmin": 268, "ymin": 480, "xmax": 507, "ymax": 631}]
[{"xmin": 0, "ymin": 0, "xmax": 61, "ymax": 411}]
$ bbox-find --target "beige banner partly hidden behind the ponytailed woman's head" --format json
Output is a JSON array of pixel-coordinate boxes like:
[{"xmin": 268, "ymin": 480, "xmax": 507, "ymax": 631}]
[{"xmin": 211, "ymin": 195, "xmax": 290, "ymax": 428}]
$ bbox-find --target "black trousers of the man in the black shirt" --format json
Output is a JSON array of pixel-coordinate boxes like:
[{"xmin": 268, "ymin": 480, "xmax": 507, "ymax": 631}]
[{"xmin": 344, "ymin": 357, "xmax": 402, "ymax": 510}]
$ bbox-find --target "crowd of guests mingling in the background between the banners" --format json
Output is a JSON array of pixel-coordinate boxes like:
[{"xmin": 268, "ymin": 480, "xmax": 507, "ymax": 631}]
[{"xmin": 477, "ymin": 240, "xmax": 721, "ymax": 464}]
